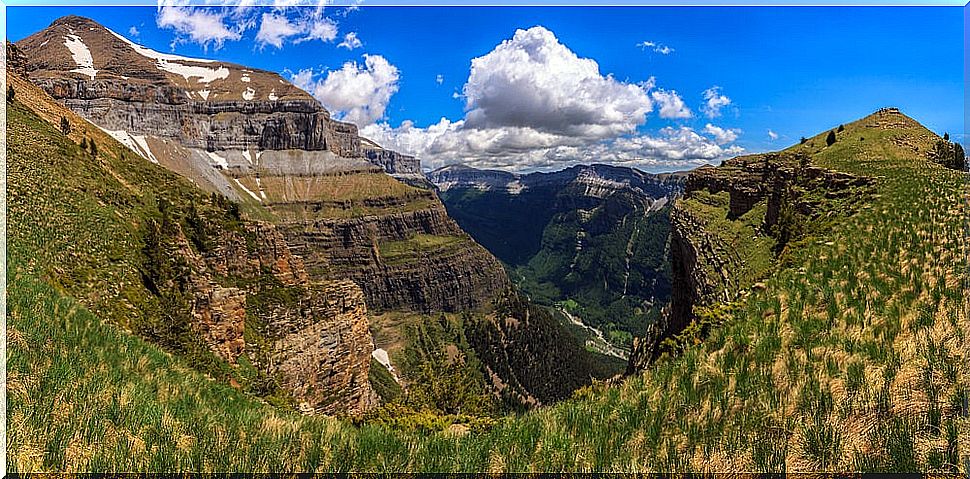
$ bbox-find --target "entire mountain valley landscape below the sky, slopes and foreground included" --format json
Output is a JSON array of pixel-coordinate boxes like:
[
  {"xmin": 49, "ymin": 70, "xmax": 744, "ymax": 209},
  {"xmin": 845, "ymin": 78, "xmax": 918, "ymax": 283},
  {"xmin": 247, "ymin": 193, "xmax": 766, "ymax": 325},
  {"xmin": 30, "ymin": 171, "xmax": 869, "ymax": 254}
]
[{"xmin": 6, "ymin": 9, "xmax": 970, "ymax": 474}]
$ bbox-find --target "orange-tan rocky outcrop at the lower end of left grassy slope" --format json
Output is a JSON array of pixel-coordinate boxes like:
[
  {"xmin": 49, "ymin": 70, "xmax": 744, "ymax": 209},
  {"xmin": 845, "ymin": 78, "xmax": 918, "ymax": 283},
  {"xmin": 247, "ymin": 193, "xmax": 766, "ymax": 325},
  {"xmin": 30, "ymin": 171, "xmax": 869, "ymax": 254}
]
[{"xmin": 179, "ymin": 224, "xmax": 377, "ymax": 415}]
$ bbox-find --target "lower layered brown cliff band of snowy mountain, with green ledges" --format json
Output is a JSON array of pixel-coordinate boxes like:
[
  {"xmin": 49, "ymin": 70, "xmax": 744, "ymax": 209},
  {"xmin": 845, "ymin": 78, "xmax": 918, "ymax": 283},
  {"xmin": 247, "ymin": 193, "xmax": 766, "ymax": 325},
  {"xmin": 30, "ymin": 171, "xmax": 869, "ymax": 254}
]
[{"xmin": 270, "ymin": 190, "xmax": 508, "ymax": 311}]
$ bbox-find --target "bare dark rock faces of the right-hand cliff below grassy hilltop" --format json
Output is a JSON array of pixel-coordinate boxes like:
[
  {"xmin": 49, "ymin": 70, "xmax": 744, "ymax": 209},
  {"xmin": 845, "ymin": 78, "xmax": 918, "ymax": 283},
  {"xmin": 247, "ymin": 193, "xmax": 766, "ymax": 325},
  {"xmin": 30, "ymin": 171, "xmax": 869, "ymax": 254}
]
[{"xmin": 630, "ymin": 152, "xmax": 874, "ymax": 371}]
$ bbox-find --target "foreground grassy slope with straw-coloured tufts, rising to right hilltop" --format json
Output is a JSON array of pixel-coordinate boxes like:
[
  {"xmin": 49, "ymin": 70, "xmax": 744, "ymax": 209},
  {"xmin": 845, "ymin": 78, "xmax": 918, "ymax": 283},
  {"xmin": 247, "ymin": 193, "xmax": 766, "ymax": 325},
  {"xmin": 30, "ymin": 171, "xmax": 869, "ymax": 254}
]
[{"xmin": 8, "ymin": 73, "xmax": 970, "ymax": 472}]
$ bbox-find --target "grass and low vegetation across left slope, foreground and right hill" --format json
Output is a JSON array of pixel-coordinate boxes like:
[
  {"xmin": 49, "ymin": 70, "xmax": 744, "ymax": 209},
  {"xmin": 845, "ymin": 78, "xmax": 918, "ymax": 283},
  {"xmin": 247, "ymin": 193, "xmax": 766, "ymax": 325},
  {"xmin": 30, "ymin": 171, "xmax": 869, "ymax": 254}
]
[{"xmin": 7, "ymin": 75, "xmax": 970, "ymax": 474}]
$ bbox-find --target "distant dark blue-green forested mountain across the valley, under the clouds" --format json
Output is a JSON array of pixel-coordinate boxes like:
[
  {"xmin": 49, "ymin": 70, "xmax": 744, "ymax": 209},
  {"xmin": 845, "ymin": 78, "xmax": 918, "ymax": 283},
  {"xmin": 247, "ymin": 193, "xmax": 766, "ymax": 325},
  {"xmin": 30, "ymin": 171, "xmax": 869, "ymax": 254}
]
[{"xmin": 428, "ymin": 165, "xmax": 685, "ymax": 347}]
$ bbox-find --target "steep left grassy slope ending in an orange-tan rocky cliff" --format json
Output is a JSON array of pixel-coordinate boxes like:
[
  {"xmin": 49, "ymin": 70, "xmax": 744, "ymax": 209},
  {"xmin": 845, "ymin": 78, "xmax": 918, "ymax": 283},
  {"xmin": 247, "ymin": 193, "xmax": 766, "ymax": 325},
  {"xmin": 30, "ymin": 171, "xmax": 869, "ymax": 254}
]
[{"xmin": 8, "ymin": 66, "xmax": 376, "ymax": 414}]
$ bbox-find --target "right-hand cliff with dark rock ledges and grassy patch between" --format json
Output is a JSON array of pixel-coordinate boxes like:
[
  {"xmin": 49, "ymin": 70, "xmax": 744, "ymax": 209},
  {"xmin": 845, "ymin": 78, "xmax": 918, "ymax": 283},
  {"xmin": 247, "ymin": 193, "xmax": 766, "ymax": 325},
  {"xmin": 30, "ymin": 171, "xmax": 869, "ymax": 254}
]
[{"xmin": 631, "ymin": 152, "xmax": 874, "ymax": 370}]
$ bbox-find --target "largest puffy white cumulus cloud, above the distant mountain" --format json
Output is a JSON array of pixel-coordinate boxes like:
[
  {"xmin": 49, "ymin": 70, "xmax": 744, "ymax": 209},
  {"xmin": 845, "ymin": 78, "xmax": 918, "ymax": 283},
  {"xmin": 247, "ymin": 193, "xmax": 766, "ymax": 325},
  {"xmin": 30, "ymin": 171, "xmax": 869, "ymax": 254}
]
[{"xmin": 361, "ymin": 27, "xmax": 742, "ymax": 170}]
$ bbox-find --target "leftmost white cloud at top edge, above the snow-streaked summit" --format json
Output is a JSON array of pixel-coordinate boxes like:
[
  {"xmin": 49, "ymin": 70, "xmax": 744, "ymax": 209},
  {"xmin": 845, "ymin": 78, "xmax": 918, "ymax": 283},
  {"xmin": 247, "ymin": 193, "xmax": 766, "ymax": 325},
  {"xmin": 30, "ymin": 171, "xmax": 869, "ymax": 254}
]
[{"xmin": 155, "ymin": 0, "xmax": 245, "ymax": 49}]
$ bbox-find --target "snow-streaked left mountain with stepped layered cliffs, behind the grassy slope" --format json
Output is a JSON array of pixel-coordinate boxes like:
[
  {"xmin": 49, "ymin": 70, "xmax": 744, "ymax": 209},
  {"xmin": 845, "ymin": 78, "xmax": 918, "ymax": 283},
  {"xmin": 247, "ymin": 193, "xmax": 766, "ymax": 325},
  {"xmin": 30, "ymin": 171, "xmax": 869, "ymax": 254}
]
[{"xmin": 16, "ymin": 16, "xmax": 507, "ymax": 311}]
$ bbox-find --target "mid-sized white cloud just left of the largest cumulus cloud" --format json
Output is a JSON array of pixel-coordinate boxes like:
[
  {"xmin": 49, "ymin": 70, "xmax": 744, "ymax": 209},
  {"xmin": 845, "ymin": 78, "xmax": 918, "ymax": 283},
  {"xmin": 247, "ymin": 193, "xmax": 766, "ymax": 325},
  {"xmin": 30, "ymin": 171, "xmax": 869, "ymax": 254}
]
[{"xmin": 291, "ymin": 54, "xmax": 400, "ymax": 126}]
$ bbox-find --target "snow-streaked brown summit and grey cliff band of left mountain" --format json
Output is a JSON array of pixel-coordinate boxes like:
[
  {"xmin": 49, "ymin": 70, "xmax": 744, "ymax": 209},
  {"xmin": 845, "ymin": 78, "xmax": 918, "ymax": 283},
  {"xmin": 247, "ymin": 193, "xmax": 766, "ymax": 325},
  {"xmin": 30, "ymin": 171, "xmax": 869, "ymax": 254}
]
[{"xmin": 17, "ymin": 16, "xmax": 406, "ymax": 173}]
